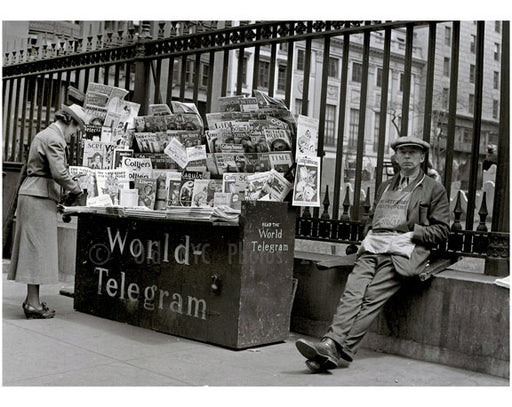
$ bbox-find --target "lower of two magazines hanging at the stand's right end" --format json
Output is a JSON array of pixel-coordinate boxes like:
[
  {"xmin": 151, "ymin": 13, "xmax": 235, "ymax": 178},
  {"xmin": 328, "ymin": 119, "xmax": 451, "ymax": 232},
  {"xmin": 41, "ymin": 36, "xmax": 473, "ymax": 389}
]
[{"xmin": 293, "ymin": 157, "xmax": 320, "ymax": 207}]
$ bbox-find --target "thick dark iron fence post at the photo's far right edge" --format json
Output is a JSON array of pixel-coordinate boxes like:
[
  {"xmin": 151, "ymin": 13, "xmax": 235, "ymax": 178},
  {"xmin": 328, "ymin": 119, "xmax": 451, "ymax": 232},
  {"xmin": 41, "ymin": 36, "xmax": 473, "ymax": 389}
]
[{"xmin": 491, "ymin": 21, "xmax": 510, "ymax": 232}]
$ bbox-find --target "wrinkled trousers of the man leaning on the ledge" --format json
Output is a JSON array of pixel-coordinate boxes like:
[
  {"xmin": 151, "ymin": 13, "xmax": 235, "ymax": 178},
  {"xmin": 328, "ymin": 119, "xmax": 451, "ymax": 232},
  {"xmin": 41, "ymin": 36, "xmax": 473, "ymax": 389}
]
[{"xmin": 324, "ymin": 253, "xmax": 402, "ymax": 357}]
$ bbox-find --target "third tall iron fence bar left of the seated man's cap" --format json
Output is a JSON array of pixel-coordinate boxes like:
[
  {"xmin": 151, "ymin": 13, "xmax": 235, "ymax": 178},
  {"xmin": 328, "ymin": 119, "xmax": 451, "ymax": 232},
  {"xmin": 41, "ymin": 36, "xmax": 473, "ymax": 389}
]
[{"xmin": 332, "ymin": 28, "xmax": 350, "ymax": 219}]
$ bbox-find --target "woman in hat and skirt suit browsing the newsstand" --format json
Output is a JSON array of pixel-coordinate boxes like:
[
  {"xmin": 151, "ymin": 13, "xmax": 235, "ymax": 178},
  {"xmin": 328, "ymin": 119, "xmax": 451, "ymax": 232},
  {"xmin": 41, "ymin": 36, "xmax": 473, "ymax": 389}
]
[{"xmin": 7, "ymin": 105, "xmax": 87, "ymax": 319}]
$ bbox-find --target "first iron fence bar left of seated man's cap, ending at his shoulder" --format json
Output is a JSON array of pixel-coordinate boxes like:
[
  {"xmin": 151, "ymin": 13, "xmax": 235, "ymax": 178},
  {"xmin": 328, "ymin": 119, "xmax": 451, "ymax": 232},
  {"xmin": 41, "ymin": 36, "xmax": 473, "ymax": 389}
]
[{"xmin": 374, "ymin": 28, "xmax": 391, "ymax": 199}]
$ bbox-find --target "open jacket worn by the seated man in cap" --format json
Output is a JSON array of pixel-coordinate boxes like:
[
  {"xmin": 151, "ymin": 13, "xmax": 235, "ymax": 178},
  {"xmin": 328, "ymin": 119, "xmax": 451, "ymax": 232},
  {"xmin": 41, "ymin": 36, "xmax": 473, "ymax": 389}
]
[{"xmin": 365, "ymin": 171, "xmax": 450, "ymax": 276}]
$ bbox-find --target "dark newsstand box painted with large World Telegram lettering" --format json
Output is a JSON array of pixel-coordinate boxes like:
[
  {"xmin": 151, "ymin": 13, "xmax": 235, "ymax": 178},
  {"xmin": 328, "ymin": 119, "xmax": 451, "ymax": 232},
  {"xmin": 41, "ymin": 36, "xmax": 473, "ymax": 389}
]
[{"xmin": 74, "ymin": 201, "xmax": 295, "ymax": 349}]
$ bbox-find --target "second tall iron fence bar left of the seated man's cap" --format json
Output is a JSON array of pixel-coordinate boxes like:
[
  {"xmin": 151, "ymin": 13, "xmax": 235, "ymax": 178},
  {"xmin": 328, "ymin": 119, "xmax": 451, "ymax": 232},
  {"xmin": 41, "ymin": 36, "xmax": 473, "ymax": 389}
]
[{"xmin": 352, "ymin": 31, "xmax": 370, "ymax": 220}]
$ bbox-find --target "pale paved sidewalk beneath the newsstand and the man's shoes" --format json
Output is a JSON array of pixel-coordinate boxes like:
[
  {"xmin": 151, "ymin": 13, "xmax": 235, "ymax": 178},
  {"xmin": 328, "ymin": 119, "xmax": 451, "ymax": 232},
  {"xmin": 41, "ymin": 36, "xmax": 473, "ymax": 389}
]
[{"xmin": 2, "ymin": 261, "xmax": 509, "ymax": 386}]
